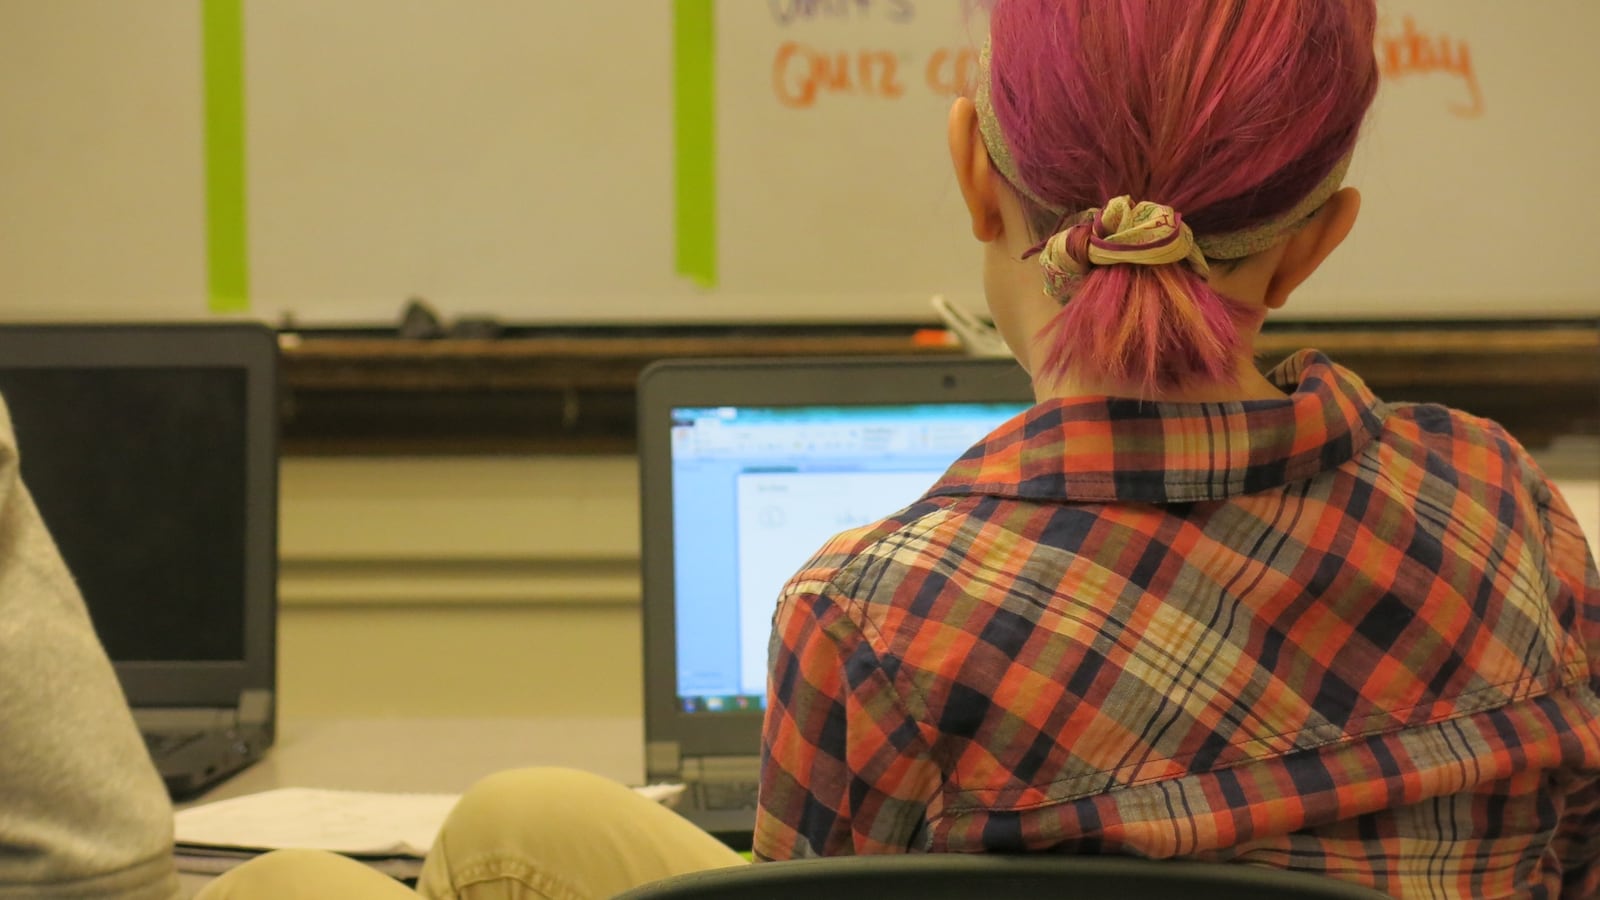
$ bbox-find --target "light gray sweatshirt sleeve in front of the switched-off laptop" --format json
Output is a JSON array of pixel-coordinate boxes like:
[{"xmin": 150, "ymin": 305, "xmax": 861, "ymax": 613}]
[{"xmin": 0, "ymin": 402, "xmax": 178, "ymax": 900}]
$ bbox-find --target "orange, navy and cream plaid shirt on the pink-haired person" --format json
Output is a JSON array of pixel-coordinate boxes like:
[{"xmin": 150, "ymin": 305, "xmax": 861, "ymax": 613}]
[{"xmin": 755, "ymin": 351, "xmax": 1600, "ymax": 897}]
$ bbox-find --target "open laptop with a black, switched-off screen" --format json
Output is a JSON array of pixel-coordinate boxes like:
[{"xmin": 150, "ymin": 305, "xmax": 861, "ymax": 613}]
[{"xmin": 0, "ymin": 325, "xmax": 278, "ymax": 798}]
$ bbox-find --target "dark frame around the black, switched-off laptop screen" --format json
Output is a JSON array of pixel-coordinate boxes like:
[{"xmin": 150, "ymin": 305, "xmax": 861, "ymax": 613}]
[{"xmin": 0, "ymin": 322, "xmax": 278, "ymax": 708}]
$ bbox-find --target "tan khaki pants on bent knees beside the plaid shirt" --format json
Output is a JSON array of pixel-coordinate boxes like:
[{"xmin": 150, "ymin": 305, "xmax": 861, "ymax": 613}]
[{"xmin": 197, "ymin": 769, "xmax": 744, "ymax": 900}]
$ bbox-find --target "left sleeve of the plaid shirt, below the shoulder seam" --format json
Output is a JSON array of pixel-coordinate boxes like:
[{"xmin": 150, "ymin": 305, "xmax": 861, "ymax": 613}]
[{"xmin": 755, "ymin": 591, "xmax": 941, "ymax": 860}]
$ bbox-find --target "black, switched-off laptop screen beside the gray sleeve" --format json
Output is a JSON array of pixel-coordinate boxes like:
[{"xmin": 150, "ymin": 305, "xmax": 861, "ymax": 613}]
[{"xmin": 0, "ymin": 365, "xmax": 246, "ymax": 663}]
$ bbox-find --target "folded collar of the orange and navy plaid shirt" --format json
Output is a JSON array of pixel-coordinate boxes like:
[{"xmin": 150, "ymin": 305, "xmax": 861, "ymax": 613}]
[{"xmin": 930, "ymin": 351, "xmax": 1382, "ymax": 503}]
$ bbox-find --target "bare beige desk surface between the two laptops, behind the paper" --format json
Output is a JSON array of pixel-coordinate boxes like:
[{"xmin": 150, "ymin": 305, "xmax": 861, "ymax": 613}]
[{"xmin": 181, "ymin": 717, "xmax": 645, "ymax": 895}]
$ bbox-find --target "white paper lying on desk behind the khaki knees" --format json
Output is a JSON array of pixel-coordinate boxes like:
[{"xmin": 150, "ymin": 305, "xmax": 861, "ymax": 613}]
[{"xmin": 176, "ymin": 785, "xmax": 683, "ymax": 857}]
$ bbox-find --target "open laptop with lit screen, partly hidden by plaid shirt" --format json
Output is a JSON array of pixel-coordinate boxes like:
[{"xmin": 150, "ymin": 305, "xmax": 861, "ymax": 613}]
[{"xmin": 638, "ymin": 357, "xmax": 1032, "ymax": 847}]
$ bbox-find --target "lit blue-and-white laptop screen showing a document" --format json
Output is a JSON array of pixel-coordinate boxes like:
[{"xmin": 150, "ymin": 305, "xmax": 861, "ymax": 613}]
[{"xmin": 670, "ymin": 402, "xmax": 1026, "ymax": 714}]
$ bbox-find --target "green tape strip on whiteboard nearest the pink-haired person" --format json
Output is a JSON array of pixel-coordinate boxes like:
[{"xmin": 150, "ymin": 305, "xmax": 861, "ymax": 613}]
[{"xmin": 672, "ymin": 0, "xmax": 717, "ymax": 288}]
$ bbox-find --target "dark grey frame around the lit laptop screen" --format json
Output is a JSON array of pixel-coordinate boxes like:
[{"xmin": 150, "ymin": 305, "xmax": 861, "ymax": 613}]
[{"xmin": 637, "ymin": 356, "xmax": 1032, "ymax": 756}]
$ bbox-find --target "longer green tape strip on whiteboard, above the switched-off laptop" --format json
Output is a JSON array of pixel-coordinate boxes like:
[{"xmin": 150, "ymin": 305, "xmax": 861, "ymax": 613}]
[{"xmin": 202, "ymin": 0, "xmax": 250, "ymax": 312}]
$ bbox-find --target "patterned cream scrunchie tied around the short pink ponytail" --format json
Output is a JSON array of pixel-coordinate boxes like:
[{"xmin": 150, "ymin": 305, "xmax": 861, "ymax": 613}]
[{"xmin": 1038, "ymin": 197, "xmax": 1211, "ymax": 299}]
